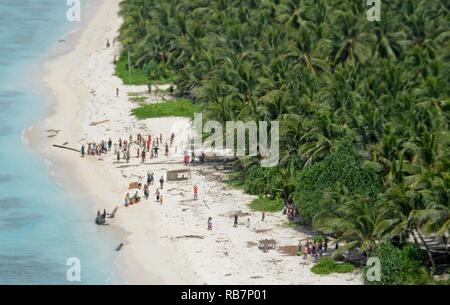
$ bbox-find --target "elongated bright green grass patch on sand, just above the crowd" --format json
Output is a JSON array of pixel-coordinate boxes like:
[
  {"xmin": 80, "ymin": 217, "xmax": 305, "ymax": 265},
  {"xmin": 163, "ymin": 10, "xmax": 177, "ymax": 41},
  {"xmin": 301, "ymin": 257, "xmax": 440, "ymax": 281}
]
[{"xmin": 131, "ymin": 99, "xmax": 198, "ymax": 120}]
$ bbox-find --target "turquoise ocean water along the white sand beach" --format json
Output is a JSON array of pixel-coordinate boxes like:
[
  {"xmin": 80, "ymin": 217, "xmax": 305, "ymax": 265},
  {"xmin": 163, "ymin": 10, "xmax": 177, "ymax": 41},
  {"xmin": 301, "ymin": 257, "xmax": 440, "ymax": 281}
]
[{"xmin": 0, "ymin": 0, "xmax": 121, "ymax": 284}]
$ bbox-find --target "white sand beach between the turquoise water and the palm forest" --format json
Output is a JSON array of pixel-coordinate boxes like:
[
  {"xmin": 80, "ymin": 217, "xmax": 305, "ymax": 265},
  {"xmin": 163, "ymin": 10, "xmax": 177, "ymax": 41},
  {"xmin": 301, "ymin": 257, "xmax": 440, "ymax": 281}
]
[{"xmin": 33, "ymin": 0, "xmax": 362, "ymax": 284}]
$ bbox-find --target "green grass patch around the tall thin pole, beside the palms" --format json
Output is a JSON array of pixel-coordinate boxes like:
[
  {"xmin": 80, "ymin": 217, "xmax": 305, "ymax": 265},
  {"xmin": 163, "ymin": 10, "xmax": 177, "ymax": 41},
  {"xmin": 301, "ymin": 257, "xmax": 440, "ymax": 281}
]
[{"xmin": 116, "ymin": 54, "xmax": 176, "ymax": 85}]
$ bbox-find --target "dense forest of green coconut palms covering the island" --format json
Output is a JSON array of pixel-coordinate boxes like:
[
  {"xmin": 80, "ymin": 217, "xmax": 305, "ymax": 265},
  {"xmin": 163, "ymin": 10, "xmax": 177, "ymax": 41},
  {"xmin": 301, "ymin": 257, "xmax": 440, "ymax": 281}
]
[{"xmin": 120, "ymin": 0, "xmax": 450, "ymax": 283}]
